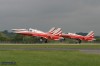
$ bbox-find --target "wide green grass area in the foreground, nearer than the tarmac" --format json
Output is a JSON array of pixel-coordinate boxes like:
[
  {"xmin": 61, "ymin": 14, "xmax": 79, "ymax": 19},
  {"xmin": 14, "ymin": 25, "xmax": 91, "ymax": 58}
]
[{"xmin": 0, "ymin": 50, "xmax": 100, "ymax": 66}]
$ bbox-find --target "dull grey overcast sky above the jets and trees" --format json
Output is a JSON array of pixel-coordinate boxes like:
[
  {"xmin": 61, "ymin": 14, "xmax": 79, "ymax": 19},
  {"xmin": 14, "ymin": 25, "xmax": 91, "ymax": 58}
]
[{"xmin": 0, "ymin": 0, "xmax": 100, "ymax": 35}]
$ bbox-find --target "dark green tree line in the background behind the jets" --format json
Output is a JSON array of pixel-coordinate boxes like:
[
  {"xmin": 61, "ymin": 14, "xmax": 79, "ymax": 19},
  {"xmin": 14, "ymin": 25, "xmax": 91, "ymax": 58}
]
[{"xmin": 0, "ymin": 30, "xmax": 100, "ymax": 43}]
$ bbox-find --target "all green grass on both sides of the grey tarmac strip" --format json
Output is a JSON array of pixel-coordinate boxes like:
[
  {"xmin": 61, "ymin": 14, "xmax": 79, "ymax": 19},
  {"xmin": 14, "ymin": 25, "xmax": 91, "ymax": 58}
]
[{"xmin": 0, "ymin": 44, "xmax": 100, "ymax": 66}]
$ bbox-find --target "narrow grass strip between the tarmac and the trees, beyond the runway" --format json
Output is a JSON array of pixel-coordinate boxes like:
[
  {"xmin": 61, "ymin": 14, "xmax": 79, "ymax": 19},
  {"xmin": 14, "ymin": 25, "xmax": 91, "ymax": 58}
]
[{"xmin": 0, "ymin": 43, "xmax": 100, "ymax": 49}]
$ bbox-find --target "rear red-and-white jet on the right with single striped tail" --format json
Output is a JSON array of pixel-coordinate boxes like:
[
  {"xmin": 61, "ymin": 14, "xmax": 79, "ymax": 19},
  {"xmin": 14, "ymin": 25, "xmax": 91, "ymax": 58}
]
[{"xmin": 61, "ymin": 31, "xmax": 95, "ymax": 43}]
